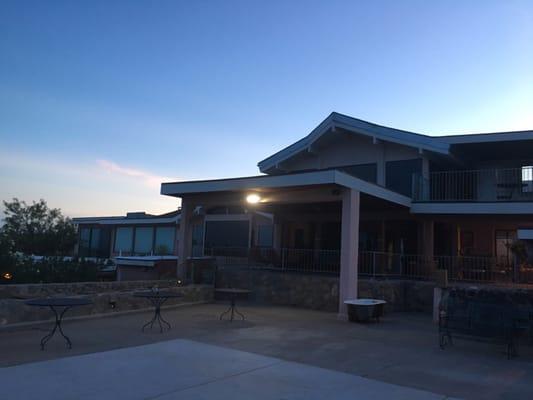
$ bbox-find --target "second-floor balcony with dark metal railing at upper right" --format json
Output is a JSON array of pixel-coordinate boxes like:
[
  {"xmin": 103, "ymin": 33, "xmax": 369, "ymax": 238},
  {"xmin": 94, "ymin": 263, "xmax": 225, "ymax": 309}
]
[{"xmin": 412, "ymin": 166, "xmax": 533, "ymax": 202}]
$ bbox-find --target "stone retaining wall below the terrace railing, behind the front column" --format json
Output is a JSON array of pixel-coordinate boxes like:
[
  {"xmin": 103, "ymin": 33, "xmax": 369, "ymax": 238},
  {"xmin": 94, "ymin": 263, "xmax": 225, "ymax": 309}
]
[{"xmin": 216, "ymin": 267, "xmax": 435, "ymax": 313}]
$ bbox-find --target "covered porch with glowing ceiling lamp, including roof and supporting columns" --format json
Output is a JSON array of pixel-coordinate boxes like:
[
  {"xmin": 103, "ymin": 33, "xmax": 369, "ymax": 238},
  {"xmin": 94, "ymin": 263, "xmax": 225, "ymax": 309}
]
[{"xmin": 161, "ymin": 170, "xmax": 412, "ymax": 315}]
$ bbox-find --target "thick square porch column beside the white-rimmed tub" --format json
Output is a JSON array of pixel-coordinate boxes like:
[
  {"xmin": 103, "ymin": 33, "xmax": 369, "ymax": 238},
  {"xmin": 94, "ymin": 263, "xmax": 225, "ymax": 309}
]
[{"xmin": 339, "ymin": 189, "xmax": 360, "ymax": 319}]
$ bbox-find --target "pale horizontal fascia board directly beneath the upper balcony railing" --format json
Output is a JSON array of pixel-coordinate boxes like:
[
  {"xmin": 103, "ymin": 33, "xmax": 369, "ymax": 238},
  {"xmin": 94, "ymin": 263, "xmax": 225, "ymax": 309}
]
[{"xmin": 411, "ymin": 201, "xmax": 533, "ymax": 214}]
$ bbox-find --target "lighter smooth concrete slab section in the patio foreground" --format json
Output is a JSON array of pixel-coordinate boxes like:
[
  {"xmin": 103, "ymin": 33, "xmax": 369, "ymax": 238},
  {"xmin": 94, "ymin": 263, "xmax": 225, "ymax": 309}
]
[{"xmin": 0, "ymin": 339, "xmax": 454, "ymax": 400}]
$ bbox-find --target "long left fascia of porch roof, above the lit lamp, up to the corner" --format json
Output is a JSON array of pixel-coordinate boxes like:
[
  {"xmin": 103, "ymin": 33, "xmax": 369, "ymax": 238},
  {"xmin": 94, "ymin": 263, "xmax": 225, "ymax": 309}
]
[{"xmin": 161, "ymin": 170, "xmax": 335, "ymax": 197}]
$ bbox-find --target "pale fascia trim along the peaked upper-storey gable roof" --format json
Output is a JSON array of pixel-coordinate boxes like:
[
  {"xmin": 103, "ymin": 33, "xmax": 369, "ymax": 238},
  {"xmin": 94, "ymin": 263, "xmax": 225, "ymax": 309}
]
[{"xmin": 258, "ymin": 112, "xmax": 450, "ymax": 172}]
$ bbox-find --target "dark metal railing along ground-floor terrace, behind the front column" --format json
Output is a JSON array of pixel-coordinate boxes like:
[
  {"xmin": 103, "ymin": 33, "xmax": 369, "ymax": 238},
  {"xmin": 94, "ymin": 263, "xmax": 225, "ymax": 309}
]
[{"xmin": 209, "ymin": 247, "xmax": 533, "ymax": 284}]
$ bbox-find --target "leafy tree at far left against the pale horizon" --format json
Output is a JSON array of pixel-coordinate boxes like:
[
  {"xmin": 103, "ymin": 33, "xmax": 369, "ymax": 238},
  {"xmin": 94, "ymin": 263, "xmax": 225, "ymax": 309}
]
[{"xmin": 0, "ymin": 198, "xmax": 77, "ymax": 256}]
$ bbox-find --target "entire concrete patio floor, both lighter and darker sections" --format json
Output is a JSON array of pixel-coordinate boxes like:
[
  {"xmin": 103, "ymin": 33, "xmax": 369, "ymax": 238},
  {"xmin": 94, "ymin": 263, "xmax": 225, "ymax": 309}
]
[{"xmin": 0, "ymin": 304, "xmax": 533, "ymax": 399}]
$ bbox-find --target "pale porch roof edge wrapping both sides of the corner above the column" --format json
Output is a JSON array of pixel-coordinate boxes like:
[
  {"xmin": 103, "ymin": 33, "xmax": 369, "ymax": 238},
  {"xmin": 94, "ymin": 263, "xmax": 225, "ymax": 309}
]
[{"xmin": 161, "ymin": 169, "xmax": 411, "ymax": 207}]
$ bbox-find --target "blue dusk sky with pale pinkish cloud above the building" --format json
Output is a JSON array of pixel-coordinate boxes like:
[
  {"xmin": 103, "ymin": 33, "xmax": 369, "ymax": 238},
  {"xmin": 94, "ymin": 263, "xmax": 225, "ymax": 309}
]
[{"xmin": 0, "ymin": 0, "xmax": 533, "ymax": 217}]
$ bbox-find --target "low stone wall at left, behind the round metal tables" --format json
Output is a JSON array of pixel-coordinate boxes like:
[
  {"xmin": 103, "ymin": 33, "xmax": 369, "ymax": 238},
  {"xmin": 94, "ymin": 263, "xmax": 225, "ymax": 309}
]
[{"xmin": 0, "ymin": 281, "xmax": 213, "ymax": 328}]
